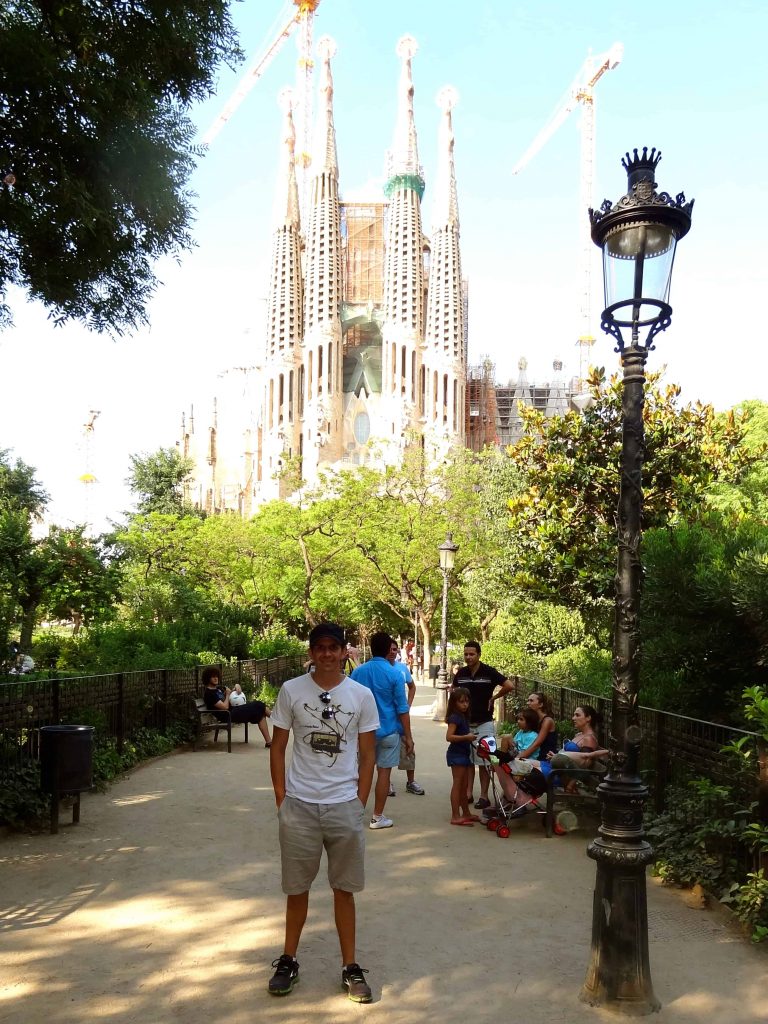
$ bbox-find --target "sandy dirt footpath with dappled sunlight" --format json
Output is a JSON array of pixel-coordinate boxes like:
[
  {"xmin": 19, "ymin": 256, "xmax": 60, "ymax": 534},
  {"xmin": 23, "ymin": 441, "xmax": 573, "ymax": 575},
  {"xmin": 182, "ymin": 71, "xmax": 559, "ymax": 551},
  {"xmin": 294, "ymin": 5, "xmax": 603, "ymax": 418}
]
[{"xmin": 0, "ymin": 688, "xmax": 768, "ymax": 1024}]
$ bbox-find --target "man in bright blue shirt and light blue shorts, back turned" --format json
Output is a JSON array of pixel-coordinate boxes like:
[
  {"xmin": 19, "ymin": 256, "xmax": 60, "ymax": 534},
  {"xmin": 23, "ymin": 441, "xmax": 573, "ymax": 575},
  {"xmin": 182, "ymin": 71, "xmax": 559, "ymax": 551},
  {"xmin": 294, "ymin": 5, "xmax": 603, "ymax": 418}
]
[{"xmin": 352, "ymin": 633, "xmax": 414, "ymax": 828}]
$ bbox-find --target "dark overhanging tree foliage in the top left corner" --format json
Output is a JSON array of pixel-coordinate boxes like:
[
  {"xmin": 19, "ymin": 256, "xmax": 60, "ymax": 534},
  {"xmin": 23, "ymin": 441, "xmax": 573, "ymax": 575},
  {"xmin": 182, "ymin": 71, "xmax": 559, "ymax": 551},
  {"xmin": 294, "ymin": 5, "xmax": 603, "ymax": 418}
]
[{"xmin": 0, "ymin": 0, "xmax": 241, "ymax": 334}]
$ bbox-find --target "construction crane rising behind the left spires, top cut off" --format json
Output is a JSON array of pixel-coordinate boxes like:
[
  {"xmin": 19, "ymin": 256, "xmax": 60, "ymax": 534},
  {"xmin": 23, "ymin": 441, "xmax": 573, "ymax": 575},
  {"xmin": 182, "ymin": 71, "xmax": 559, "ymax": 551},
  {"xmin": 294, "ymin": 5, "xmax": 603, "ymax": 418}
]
[{"xmin": 203, "ymin": 0, "xmax": 321, "ymax": 208}]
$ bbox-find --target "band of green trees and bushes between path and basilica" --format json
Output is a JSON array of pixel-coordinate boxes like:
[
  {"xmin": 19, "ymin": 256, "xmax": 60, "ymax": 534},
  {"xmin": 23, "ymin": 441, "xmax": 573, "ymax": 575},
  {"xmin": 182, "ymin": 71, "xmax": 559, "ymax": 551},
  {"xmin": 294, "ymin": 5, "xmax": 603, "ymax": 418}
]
[{"xmin": 0, "ymin": 380, "xmax": 768, "ymax": 724}]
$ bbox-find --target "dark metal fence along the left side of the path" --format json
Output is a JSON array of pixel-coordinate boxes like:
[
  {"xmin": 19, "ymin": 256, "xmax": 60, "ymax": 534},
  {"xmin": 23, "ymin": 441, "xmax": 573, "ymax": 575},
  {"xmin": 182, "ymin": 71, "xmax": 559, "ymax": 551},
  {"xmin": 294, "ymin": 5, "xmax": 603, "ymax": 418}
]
[{"xmin": 0, "ymin": 656, "xmax": 304, "ymax": 770}]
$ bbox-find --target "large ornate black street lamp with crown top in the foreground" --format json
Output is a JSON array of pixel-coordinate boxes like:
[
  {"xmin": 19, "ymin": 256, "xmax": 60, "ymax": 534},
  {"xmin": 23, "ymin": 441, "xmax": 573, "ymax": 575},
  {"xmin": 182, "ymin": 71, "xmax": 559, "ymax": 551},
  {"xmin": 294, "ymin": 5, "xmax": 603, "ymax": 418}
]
[{"xmin": 581, "ymin": 147, "xmax": 693, "ymax": 1016}]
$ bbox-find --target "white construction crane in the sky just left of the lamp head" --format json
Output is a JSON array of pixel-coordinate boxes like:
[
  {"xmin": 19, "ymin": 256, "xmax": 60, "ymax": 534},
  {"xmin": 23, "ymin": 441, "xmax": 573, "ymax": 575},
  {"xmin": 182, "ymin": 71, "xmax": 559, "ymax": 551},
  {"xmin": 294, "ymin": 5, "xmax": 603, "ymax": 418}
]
[{"xmin": 512, "ymin": 43, "xmax": 624, "ymax": 381}]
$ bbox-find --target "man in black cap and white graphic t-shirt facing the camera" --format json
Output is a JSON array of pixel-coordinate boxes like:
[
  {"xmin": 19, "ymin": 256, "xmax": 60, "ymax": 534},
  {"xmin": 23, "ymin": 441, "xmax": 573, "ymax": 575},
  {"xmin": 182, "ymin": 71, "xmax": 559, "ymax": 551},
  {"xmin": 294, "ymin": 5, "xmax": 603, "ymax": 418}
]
[{"xmin": 269, "ymin": 623, "xmax": 379, "ymax": 1002}]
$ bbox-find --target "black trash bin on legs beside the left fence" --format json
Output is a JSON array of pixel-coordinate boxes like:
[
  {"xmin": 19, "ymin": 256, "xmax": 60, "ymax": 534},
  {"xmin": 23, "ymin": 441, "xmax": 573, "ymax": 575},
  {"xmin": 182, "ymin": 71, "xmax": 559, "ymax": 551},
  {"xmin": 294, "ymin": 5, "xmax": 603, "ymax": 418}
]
[{"xmin": 40, "ymin": 725, "xmax": 93, "ymax": 833}]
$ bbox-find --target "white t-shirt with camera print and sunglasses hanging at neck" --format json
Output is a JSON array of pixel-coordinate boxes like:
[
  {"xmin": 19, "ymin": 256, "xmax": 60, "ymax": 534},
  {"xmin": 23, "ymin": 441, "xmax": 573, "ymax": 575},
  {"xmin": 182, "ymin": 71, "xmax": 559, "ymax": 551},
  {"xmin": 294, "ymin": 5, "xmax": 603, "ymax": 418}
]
[{"xmin": 271, "ymin": 674, "xmax": 379, "ymax": 804}]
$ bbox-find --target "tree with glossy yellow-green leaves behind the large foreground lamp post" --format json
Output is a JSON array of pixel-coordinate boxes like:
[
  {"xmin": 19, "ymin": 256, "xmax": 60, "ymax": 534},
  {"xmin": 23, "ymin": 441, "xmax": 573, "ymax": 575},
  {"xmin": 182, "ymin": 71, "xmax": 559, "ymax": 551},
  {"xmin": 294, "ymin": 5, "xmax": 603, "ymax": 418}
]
[{"xmin": 510, "ymin": 370, "xmax": 760, "ymax": 622}]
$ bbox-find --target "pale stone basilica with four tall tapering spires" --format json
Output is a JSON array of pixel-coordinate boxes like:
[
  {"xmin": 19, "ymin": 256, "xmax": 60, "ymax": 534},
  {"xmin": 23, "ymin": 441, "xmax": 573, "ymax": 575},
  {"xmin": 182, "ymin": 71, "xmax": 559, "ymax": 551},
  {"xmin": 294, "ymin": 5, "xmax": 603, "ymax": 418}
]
[{"xmin": 179, "ymin": 37, "xmax": 467, "ymax": 515}]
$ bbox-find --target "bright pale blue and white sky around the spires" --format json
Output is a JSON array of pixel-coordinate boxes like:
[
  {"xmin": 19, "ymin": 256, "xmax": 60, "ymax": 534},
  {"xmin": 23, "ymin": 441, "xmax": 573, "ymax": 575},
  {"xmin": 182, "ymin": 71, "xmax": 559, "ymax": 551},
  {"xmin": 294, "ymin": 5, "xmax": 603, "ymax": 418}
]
[{"xmin": 0, "ymin": 0, "xmax": 768, "ymax": 527}]
